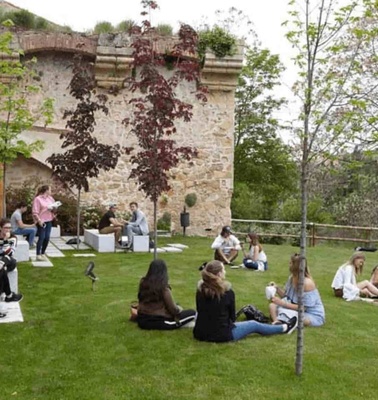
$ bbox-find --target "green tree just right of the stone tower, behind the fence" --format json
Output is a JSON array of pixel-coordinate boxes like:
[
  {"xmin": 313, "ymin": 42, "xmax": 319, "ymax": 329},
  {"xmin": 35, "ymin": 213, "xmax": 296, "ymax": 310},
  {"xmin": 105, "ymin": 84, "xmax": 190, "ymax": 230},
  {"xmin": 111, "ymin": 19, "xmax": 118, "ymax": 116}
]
[{"xmin": 233, "ymin": 45, "xmax": 298, "ymax": 219}]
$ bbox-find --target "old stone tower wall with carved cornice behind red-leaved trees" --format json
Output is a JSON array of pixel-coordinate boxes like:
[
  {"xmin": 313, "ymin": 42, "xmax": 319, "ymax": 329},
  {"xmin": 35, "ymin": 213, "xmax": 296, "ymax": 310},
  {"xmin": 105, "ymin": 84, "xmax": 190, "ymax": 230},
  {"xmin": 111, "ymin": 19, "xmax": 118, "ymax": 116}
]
[{"xmin": 5, "ymin": 31, "xmax": 242, "ymax": 235}]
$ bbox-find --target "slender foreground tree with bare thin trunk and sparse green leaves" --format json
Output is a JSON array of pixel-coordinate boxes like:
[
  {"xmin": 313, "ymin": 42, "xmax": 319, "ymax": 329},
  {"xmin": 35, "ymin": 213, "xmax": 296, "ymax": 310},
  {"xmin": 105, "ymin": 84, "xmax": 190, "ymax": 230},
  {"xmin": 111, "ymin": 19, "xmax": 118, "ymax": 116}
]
[{"xmin": 287, "ymin": 0, "xmax": 376, "ymax": 375}]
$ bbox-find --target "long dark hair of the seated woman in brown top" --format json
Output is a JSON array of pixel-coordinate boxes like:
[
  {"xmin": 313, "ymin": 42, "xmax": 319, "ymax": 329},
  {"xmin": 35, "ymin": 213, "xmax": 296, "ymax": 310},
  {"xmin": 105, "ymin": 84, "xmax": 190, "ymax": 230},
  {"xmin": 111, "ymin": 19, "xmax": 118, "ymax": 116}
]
[{"xmin": 138, "ymin": 259, "xmax": 169, "ymax": 302}]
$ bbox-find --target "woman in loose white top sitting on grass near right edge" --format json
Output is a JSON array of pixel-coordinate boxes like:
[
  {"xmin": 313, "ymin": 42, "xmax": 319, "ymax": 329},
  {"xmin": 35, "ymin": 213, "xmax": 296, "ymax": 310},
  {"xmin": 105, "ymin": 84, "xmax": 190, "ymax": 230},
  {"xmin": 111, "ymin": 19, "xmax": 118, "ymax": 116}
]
[{"xmin": 331, "ymin": 252, "xmax": 378, "ymax": 301}]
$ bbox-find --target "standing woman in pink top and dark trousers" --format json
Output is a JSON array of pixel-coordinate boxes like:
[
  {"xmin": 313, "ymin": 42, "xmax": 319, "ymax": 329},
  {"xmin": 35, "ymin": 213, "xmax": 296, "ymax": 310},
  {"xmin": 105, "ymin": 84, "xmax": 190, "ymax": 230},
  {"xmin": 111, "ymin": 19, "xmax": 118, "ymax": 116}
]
[{"xmin": 33, "ymin": 185, "xmax": 55, "ymax": 261}]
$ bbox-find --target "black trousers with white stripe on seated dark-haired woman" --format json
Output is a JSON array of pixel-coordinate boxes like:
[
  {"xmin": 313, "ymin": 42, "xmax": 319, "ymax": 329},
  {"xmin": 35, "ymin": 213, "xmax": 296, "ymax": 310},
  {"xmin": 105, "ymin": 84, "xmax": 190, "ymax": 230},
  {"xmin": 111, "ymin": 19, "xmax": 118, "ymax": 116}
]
[{"xmin": 137, "ymin": 310, "xmax": 196, "ymax": 331}]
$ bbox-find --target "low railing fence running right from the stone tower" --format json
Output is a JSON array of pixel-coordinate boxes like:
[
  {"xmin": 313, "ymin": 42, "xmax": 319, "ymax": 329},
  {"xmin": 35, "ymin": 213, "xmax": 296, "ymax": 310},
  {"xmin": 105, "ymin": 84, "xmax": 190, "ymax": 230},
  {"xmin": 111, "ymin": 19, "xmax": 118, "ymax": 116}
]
[{"xmin": 231, "ymin": 219, "xmax": 378, "ymax": 246}]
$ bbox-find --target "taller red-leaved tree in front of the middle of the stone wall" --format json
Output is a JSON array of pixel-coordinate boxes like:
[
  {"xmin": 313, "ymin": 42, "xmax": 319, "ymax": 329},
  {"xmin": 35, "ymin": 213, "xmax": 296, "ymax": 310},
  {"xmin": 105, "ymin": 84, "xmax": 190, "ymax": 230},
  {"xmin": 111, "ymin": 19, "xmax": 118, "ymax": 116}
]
[{"xmin": 123, "ymin": 0, "xmax": 207, "ymax": 258}]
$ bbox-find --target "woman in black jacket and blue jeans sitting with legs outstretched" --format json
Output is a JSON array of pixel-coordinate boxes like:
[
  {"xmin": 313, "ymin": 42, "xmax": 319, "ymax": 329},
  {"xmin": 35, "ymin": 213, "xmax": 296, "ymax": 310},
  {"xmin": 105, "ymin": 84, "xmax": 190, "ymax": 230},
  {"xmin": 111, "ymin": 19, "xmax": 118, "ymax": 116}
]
[{"xmin": 193, "ymin": 260, "xmax": 297, "ymax": 342}]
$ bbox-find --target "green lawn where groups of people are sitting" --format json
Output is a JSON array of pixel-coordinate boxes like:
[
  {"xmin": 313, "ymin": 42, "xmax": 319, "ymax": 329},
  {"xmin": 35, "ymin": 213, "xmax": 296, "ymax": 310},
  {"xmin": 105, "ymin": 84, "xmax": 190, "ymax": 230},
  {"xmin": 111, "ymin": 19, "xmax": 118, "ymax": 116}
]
[{"xmin": 0, "ymin": 237, "xmax": 378, "ymax": 400}]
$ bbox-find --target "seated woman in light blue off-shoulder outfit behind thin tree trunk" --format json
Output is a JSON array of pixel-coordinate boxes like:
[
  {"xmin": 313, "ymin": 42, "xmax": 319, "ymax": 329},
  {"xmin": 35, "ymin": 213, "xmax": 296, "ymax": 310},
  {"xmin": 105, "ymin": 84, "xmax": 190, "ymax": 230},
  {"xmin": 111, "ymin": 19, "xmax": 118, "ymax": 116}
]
[{"xmin": 269, "ymin": 254, "xmax": 325, "ymax": 326}]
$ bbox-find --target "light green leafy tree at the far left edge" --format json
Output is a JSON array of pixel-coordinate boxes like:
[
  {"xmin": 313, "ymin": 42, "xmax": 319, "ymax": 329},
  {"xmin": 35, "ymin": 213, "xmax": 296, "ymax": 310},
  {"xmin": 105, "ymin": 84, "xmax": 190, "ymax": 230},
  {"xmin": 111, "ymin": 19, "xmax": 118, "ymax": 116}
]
[{"xmin": 0, "ymin": 21, "xmax": 53, "ymax": 215}]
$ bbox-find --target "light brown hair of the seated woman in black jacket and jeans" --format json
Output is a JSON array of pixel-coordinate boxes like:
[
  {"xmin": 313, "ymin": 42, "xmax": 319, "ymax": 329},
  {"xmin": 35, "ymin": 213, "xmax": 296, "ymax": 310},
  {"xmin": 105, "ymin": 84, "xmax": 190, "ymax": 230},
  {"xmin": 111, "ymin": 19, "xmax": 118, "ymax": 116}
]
[{"xmin": 200, "ymin": 260, "xmax": 229, "ymax": 299}]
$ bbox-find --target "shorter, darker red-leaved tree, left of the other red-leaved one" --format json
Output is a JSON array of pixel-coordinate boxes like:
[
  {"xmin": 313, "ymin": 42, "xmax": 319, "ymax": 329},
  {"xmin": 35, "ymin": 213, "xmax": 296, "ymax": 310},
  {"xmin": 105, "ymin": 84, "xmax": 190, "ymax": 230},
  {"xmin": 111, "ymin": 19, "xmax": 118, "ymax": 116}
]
[{"xmin": 47, "ymin": 54, "xmax": 121, "ymax": 248}]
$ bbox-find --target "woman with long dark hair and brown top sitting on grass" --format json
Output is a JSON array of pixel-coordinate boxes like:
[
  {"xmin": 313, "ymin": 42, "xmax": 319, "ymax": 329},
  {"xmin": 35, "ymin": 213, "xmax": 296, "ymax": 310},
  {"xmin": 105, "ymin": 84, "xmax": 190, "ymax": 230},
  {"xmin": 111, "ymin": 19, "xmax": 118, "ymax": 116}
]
[{"xmin": 137, "ymin": 260, "xmax": 196, "ymax": 330}]
